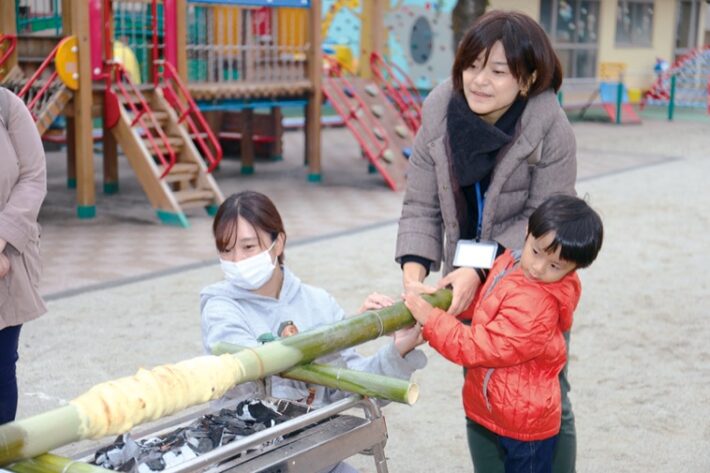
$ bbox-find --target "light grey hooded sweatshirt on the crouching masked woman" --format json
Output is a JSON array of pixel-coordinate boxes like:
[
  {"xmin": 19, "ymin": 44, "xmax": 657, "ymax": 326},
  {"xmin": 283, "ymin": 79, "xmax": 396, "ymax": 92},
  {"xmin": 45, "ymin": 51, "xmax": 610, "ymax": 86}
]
[{"xmin": 200, "ymin": 267, "xmax": 426, "ymax": 407}]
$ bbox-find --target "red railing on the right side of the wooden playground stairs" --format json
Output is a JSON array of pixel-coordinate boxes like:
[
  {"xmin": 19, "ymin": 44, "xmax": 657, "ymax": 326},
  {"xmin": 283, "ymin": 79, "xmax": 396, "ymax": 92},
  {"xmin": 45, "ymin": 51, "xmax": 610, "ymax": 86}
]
[{"xmin": 153, "ymin": 61, "xmax": 222, "ymax": 172}]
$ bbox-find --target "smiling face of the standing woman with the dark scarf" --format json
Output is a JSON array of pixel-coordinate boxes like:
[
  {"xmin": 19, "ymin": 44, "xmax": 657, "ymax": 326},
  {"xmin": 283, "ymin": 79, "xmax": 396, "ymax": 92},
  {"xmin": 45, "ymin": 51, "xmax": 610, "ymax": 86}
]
[{"xmin": 463, "ymin": 41, "xmax": 520, "ymax": 125}]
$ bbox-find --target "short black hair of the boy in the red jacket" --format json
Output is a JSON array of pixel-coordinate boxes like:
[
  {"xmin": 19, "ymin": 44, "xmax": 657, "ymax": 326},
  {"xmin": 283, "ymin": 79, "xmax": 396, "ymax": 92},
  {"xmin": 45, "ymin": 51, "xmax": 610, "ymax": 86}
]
[{"xmin": 528, "ymin": 195, "xmax": 604, "ymax": 268}]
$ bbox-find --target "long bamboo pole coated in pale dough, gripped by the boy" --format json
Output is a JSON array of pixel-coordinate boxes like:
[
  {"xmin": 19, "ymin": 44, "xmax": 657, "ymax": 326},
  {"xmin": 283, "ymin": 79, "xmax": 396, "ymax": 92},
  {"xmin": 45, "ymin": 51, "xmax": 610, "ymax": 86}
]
[{"xmin": 0, "ymin": 290, "xmax": 451, "ymax": 466}]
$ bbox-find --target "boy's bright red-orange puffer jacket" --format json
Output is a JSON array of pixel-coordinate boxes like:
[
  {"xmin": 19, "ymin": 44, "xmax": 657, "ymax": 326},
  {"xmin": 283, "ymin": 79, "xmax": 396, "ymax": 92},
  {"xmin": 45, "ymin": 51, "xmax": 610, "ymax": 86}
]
[{"xmin": 423, "ymin": 250, "xmax": 581, "ymax": 441}]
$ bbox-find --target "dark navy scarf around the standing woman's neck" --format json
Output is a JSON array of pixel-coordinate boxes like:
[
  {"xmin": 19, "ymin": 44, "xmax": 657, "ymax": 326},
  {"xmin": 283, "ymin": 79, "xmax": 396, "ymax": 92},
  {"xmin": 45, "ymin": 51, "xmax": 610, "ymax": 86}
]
[{"xmin": 446, "ymin": 92, "xmax": 526, "ymax": 187}]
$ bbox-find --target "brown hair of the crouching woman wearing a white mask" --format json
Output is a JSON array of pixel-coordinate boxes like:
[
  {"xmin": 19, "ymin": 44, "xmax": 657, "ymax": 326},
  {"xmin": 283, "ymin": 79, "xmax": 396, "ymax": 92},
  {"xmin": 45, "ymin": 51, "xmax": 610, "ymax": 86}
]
[{"xmin": 212, "ymin": 191, "xmax": 286, "ymax": 264}]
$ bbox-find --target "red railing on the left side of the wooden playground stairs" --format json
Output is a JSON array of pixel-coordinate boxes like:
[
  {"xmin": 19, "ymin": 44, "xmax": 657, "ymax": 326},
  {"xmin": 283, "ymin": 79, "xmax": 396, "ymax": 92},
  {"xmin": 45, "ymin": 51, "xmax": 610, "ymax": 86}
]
[{"xmin": 109, "ymin": 62, "xmax": 177, "ymax": 175}]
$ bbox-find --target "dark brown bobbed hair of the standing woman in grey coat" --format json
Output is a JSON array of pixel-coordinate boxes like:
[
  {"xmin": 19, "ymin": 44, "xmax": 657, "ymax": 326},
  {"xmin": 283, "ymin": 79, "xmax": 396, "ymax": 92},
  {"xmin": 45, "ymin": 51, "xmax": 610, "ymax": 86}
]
[{"xmin": 451, "ymin": 10, "xmax": 562, "ymax": 96}]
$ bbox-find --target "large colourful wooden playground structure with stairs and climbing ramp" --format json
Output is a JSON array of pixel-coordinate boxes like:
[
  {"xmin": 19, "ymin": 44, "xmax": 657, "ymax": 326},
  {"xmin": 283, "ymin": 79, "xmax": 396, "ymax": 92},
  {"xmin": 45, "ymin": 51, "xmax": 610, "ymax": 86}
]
[{"xmin": 0, "ymin": 0, "xmax": 428, "ymax": 219}]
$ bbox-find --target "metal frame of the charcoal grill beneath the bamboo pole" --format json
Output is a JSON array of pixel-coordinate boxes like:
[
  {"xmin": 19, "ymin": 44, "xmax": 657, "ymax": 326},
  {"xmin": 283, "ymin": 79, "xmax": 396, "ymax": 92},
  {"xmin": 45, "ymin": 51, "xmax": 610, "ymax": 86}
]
[{"xmin": 75, "ymin": 383, "xmax": 388, "ymax": 473}]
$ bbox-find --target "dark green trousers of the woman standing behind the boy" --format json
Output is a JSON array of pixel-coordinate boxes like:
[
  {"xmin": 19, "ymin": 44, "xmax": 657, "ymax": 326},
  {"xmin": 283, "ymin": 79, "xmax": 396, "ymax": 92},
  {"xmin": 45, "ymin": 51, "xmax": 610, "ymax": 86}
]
[{"xmin": 466, "ymin": 332, "xmax": 577, "ymax": 473}]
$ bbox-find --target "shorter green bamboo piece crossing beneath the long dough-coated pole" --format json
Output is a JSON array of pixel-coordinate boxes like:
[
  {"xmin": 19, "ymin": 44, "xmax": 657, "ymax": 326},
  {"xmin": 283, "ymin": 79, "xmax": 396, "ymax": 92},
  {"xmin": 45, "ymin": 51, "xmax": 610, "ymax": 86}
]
[{"xmin": 212, "ymin": 342, "xmax": 419, "ymax": 406}]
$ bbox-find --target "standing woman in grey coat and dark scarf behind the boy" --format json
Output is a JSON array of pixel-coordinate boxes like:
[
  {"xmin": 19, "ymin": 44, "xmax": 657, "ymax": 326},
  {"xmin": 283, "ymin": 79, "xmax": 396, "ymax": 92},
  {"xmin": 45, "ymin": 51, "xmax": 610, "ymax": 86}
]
[{"xmin": 395, "ymin": 11, "xmax": 577, "ymax": 473}]
